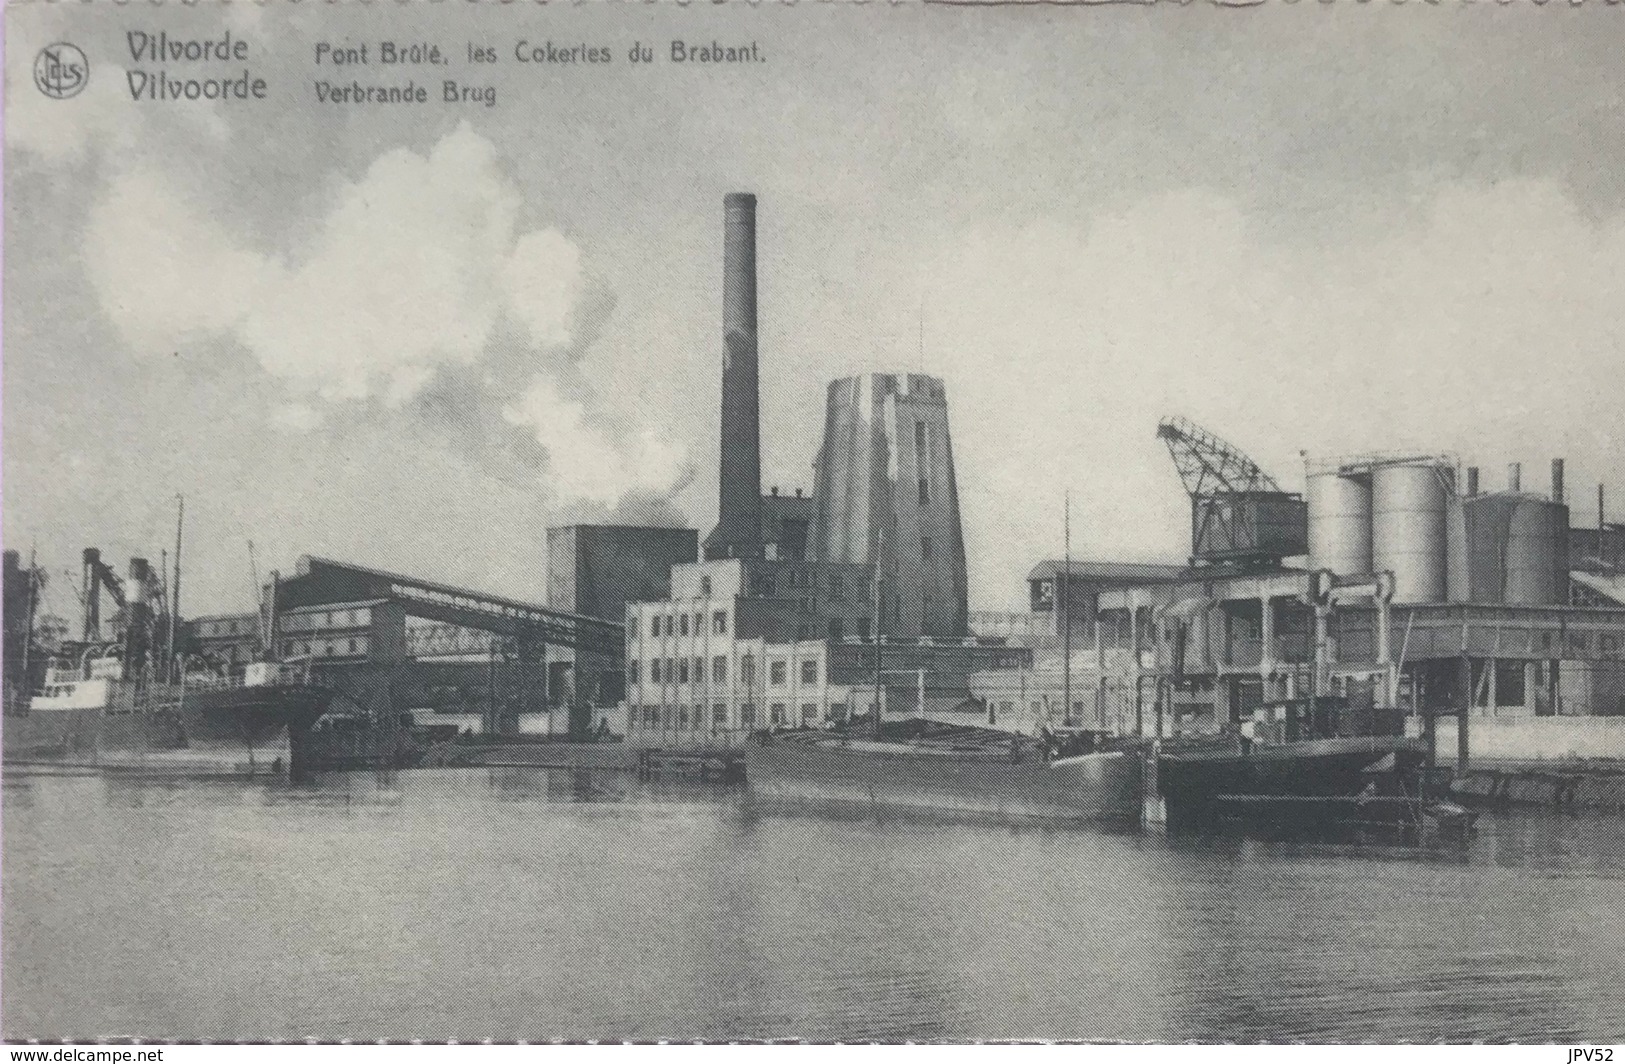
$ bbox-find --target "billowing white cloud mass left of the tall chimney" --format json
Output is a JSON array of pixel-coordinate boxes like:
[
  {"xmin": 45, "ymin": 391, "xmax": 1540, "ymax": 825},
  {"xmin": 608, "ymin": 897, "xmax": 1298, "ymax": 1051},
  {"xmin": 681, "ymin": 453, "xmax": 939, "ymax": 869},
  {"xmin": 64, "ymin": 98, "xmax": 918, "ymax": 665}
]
[{"xmin": 85, "ymin": 123, "xmax": 686, "ymax": 505}]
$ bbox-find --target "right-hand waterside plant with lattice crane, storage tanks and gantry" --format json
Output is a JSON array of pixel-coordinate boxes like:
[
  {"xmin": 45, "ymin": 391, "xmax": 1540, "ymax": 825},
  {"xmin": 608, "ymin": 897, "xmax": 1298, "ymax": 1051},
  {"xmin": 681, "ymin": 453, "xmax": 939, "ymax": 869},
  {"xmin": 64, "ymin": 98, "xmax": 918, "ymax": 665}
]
[{"xmin": 972, "ymin": 422, "xmax": 1625, "ymax": 759}]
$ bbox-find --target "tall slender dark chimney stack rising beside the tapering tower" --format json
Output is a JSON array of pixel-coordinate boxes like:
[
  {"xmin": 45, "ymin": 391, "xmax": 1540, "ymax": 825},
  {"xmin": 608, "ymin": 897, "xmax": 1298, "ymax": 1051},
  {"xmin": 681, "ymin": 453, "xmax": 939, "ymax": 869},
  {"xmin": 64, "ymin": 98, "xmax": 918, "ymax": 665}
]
[{"xmin": 705, "ymin": 192, "xmax": 762, "ymax": 560}]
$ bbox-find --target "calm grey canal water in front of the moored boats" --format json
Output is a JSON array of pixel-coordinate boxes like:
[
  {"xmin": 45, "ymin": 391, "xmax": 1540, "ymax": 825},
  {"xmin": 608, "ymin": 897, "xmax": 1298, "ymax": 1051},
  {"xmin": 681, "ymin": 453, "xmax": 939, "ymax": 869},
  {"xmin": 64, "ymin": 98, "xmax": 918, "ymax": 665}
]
[{"xmin": 0, "ymin": 768, "xmax": 1625, "ymax": 1043}]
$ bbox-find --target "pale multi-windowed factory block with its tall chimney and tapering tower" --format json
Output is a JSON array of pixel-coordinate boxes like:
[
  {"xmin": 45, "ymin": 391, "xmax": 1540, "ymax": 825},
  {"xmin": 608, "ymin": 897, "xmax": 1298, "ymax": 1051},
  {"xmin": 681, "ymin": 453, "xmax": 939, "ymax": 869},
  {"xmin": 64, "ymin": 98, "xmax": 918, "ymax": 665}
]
[{"xmin": 626, "ymin": 193, "xmax": 994, "ymax": 741}]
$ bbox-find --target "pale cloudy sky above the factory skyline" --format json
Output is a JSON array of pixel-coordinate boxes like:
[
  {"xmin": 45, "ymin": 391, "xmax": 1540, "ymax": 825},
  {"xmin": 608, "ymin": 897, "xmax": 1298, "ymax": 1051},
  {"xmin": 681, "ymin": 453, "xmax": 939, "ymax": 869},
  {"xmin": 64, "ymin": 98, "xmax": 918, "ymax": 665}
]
[{"xmin": 0, "ymin": 3, "xmax": 1625, "ymax": 616}]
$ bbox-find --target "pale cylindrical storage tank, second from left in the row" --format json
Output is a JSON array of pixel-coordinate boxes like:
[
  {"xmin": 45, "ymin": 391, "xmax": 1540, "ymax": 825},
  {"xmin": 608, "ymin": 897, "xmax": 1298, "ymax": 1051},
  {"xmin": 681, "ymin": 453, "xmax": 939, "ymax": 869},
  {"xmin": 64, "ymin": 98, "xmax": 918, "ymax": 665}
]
[{"xmin": 1372, "ymin": 461, "xmax": 1454, "ymax": 603}]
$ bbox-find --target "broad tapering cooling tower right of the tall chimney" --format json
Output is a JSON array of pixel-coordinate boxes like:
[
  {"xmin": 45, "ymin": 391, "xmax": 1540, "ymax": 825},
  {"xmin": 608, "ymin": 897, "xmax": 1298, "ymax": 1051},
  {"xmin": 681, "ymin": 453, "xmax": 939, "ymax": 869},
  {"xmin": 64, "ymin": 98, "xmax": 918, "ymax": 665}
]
[{"xmin": 811, "ymin": 374, "xmax": 967, "ymax": 638}]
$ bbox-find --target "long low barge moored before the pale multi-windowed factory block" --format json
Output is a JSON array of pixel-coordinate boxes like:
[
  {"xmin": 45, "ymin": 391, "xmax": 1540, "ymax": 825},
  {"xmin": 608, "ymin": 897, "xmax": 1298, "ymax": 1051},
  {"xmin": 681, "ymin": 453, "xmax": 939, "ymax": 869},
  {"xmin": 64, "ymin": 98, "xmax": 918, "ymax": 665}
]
[{"xmin": 743, "ymin": 721, "xmax": 1141, "ymax": 825}]
